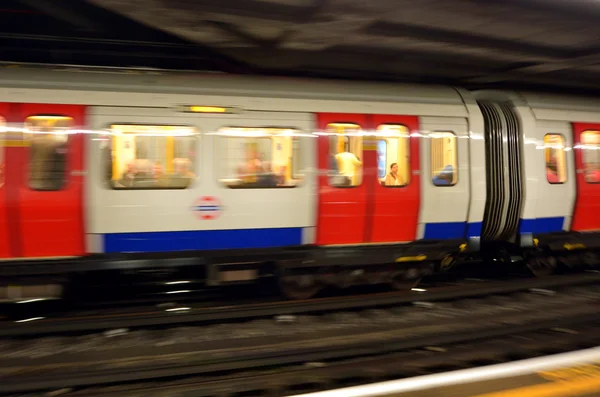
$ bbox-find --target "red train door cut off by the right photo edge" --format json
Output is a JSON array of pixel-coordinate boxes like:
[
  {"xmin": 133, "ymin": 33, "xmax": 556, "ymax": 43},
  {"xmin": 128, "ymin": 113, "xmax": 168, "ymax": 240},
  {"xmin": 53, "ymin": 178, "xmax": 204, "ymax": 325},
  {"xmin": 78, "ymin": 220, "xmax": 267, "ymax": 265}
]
[{"xmin": 571, "ymin": 123, "xmax": 600, "ymax": 232}]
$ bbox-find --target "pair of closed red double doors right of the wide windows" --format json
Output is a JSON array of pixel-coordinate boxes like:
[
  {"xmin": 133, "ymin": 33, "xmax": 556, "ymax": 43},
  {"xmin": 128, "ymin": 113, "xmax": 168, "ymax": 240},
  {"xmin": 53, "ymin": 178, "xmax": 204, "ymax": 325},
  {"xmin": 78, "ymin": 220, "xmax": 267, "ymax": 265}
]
[{"xmin": 317, "ymin": 113, "xmax": 419, "ymax": 245}]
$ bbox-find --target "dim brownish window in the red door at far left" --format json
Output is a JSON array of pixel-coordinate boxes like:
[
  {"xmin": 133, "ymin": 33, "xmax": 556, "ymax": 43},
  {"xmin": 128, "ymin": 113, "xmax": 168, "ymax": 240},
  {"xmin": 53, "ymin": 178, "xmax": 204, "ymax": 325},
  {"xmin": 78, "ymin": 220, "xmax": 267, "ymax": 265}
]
[{"xmin": 24, "ymin": 115, "xmax": 73, "ymax": 191}]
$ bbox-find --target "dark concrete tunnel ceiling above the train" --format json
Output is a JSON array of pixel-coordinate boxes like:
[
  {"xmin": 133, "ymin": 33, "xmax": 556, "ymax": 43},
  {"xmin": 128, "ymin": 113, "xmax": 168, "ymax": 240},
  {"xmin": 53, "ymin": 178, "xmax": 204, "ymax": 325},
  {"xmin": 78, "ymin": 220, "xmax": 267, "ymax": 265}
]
[{"xmin": 0, "ymin": 0, "xmax": 600, "ymax": 94}]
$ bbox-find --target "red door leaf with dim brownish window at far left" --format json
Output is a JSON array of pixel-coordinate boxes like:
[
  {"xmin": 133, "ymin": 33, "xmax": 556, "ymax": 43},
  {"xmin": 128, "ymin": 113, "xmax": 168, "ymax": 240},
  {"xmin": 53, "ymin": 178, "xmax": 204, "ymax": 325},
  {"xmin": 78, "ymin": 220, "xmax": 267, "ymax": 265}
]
[{"xmin": 10, "ymin": 104, "xmax": 85, "ymax": 257}]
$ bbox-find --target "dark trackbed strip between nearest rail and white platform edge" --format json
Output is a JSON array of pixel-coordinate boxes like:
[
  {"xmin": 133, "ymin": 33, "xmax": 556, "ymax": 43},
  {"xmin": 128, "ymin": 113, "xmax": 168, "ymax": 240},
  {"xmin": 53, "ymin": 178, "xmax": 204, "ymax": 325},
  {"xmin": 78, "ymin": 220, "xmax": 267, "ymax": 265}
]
[{"xmin": 39, "ymin": 322, "xmax": 600, "ymax": 397}]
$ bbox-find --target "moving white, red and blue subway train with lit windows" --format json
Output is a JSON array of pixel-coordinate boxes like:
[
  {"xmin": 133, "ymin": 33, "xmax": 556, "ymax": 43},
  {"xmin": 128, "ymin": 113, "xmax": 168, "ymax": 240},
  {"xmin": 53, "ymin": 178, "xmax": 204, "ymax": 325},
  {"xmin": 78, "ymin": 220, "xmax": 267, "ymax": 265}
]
[{"xmin": 0, "ymin": 65, "xmax": 600, "ymax": 299}]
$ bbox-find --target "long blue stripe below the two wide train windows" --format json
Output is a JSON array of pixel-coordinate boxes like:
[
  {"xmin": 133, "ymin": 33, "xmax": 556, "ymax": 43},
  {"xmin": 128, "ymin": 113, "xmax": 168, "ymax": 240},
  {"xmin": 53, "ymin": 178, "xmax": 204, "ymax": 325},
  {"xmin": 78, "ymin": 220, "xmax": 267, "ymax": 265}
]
[{"xmin": 104, "ymin": 227, "xmax": 302, "ymax": 253}]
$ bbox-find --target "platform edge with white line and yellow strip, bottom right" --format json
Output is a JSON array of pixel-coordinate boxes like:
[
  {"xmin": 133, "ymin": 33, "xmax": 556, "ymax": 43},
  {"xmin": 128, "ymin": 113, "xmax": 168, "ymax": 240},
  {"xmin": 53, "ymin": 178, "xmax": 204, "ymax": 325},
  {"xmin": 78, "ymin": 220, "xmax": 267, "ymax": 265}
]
[{"xmin": 295, "ymin": 347, "xmax": 600, "ymax": 397}]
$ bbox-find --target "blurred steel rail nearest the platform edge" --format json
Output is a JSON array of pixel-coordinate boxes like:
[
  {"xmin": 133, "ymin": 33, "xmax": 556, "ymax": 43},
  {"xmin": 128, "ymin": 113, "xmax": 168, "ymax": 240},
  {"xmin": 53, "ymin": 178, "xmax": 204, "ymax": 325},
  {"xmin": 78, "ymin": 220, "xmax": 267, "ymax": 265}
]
[{"xmin": 0, "ymin": 278, "xmax": 600, "ymax": 393}]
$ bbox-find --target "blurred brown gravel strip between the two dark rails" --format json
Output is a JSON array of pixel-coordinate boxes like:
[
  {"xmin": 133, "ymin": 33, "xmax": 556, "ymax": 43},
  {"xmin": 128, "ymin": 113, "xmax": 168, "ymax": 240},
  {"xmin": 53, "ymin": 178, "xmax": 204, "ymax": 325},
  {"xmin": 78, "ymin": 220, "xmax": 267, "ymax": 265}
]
[{"xmin": 0, "ymin": 285, "xmax": 600, "ymax": 367}]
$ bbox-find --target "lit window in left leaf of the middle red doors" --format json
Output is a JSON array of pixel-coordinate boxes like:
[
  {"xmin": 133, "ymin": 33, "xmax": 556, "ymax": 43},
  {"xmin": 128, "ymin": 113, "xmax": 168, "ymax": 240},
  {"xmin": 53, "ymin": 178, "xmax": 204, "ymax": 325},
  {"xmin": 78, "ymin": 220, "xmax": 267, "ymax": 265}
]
[{"xmin": 327, "ymin": 123, "xmax": 363, "ymax": 187}]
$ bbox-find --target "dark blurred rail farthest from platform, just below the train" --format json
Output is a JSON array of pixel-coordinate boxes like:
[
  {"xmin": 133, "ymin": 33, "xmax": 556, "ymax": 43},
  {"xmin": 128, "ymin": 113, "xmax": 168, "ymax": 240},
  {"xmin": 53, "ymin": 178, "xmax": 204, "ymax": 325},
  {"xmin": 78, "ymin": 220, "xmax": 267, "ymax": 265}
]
[{"xmin": 0, "ymin": 272, "xmax": 600, "ymax": 338}]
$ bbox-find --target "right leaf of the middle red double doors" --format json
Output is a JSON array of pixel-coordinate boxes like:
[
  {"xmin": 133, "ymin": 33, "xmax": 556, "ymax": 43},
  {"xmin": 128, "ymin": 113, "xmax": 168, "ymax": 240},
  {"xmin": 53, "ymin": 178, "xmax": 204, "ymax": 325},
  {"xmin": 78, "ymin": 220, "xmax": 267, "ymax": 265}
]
[{"xmin": 369, "ymin": 115, "xmax": 420, "ymax": 243}]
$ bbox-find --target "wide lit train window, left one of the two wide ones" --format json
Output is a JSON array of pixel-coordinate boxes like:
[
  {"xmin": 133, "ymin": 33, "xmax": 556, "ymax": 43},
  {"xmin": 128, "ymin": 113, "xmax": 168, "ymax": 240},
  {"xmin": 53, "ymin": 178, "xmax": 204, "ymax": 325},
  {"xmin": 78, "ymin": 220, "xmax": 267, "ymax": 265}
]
[{"xmin": 103, "ymin": 124, "xmax": 198, "ymax": 190}]
